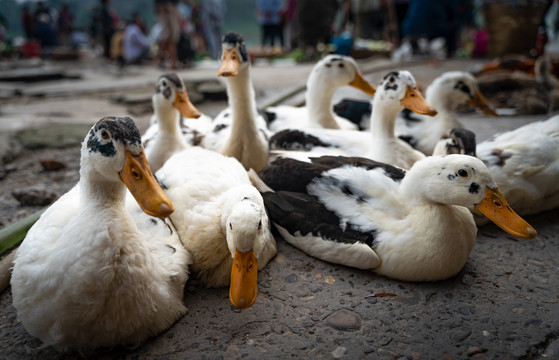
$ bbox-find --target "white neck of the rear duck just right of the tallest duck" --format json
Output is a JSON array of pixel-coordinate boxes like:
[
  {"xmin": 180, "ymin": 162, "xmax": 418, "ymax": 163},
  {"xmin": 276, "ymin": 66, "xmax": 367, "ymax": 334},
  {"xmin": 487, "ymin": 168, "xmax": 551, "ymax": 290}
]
[{"xmin": 305, "ymin": 81, "xmax": 340, "ymax": 129}]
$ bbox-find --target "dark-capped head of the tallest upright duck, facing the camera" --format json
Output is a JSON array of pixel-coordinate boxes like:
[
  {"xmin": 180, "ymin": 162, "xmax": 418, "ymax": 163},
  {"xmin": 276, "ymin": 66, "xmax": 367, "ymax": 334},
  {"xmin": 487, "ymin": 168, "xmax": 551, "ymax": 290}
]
[{"xmin": 217, "ymin": 32, "xmax": 250, "ymax": 77}]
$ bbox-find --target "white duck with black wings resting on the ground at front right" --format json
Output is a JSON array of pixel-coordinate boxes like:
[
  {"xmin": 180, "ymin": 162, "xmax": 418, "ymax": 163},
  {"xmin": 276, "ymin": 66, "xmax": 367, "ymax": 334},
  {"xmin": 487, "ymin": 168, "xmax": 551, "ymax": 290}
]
[{"xmin": 251, "ymin": 154, "xmax": 537, "ymax": 282}]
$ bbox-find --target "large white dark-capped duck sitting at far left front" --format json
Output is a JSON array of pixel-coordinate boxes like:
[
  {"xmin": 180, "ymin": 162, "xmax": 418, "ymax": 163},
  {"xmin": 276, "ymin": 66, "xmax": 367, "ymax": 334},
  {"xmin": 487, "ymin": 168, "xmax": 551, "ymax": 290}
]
[{"xmin": 11, "ymin": 117, "xmax": 191, "ymax": 356}]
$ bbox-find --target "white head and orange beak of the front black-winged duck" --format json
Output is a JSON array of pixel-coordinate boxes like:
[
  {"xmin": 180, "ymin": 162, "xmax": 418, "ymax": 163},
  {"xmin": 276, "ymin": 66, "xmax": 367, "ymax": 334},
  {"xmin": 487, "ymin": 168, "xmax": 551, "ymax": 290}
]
[{"xmin": 406, "ymin": 155, "xmax": 537, "ymax": 239}]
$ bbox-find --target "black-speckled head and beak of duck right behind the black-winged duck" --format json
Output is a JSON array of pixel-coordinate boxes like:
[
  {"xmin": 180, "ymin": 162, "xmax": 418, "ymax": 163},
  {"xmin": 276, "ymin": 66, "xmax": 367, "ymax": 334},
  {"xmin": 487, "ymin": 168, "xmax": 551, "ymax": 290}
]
[{"xmin": 373, "ymin": 70, "xmax": 437, "ymax": 116}]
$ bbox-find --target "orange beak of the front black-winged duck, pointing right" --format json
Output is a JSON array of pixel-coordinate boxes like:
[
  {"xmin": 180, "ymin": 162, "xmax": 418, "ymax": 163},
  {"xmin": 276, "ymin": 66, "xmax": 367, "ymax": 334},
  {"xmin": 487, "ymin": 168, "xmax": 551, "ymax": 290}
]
[{"xmin": 476, "ymin": 188, "xmax": 538, "ymax": 239}]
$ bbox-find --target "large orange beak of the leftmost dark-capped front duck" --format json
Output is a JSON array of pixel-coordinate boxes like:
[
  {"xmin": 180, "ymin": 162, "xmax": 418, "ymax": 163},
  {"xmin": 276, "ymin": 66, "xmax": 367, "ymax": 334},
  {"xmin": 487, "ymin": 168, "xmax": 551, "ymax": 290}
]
[{"xmin": 119, "ymin": 150, "xmax": 175, "ymax": 218}]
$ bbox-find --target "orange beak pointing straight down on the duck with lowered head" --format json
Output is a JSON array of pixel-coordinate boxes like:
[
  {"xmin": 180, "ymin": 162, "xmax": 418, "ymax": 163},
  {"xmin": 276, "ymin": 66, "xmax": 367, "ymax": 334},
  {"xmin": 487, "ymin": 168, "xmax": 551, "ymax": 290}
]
[{"xmin": 229, "ymin": 249, "xmax": 258, "ymax": 309}]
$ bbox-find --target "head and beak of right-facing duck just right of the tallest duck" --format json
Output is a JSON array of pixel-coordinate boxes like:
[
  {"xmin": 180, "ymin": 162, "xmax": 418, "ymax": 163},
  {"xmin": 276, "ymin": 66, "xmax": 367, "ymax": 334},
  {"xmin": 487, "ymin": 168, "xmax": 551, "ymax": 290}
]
[{"xmin": 307, "ymin": 55, "xmax": 376, "ymax": 96}]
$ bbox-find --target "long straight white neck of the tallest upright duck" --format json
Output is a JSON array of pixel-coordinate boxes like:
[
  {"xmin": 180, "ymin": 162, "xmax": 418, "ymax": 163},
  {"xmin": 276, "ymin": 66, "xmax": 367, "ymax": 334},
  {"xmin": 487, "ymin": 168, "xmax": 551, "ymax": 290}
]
[{"xmin": 227, "ymin": 67, "xmax": 258, "ymax": 142}]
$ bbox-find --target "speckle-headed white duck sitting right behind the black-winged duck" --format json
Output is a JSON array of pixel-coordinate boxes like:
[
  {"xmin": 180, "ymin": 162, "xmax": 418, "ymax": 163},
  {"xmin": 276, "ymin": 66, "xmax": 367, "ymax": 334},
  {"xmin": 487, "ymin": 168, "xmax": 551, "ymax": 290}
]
[{"xmin": 270, "ymin": 70, "xmax": 437, "ymax": 169}]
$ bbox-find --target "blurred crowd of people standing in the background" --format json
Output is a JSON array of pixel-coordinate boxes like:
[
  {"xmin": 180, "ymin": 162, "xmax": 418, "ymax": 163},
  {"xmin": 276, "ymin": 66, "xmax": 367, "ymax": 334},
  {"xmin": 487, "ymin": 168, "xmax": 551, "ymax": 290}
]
[{"xmin": 0, "ymin": 0, "xmax": 559, "ymax": 69}]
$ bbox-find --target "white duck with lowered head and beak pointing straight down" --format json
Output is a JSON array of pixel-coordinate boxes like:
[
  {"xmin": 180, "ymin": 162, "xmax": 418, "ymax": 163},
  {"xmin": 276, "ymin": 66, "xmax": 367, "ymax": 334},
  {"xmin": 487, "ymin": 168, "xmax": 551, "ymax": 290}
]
[{"xmin": 156, "ymin": 147, "xmax": 277, "ymax": 309}]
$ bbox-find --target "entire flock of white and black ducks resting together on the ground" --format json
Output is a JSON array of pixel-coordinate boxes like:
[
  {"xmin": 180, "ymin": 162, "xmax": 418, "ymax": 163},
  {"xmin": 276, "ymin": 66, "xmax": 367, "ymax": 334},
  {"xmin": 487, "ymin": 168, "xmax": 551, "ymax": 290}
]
[{"xmin": 11, "ymin": 33, "xmax": 559, "ymax": 354}]
